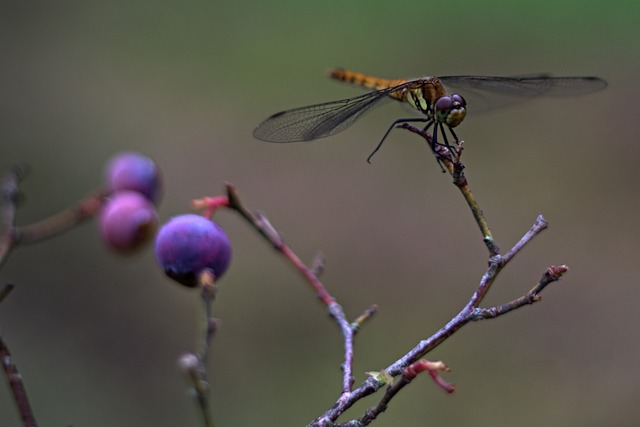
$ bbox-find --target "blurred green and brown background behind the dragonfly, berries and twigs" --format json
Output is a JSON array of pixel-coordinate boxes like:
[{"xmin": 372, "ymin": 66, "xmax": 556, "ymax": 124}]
[{"xmin": 0, "ymin": 0, "xmax": 640, "ymax": 427}]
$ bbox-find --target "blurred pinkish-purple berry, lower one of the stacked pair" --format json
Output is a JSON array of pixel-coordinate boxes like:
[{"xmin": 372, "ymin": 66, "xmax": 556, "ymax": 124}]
[{"xmin": 99, "ymin": 191, "xmax": 158, "ymax": 252}]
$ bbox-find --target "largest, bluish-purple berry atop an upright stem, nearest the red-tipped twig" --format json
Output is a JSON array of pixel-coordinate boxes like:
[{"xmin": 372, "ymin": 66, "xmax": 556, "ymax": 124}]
[{"xmin": 156, "ymin": 214, "xmax": 231, "ymax": 287}]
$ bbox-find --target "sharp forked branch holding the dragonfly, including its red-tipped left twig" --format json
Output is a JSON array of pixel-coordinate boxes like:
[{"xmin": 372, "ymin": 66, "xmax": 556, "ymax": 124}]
[{"xmin": 196, "ymin": 123, "xmax": 567, "ymax": 427}]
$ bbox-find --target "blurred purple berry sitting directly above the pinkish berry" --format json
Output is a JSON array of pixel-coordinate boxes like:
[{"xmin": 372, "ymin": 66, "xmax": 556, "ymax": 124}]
[{"xmin": 106, "ymin": 152, "xmax": 162, "ymax": 205}]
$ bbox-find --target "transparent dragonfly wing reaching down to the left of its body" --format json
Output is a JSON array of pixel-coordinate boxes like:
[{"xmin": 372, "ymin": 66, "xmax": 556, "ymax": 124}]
[{"xmin": 253, "ymin": 87, "xmax": 397, "ymax": 142}]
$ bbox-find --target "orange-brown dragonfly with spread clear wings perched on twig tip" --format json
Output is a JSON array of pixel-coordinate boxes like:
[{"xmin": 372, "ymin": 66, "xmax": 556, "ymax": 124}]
[{"xmin": 253, "ymin": 68, "xmax": 607, "ymax": 161}]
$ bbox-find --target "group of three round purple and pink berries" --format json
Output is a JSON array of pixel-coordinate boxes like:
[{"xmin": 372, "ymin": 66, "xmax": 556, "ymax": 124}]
[{"xmin": 99, "ymin": 152, "xmax": 231, "ymax": 287}]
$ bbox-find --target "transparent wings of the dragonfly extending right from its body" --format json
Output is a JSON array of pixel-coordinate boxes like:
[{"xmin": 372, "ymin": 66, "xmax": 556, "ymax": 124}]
[{"xmin": 440, "ymin": 75, "xmax": 607, "ymax": 111}]
